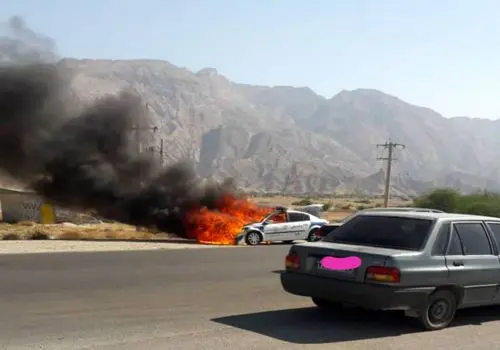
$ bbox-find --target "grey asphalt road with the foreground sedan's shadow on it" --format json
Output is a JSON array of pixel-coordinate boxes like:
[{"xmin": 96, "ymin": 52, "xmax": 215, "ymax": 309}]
[{"xmin": 0, "ymin": 246, "xmax": 500, "ymax": 350}]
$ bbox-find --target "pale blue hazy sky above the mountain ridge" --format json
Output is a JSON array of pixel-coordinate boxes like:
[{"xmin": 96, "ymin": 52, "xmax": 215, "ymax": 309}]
[{"xmin": 0, "ymin": 0, "xmax": 500, "ymax": 119}]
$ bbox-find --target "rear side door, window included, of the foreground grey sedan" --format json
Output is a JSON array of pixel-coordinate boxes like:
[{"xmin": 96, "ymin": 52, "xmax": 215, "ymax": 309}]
[{"xmin": 446, "ymin": 221, "xmax": 500, "ymax": 306}]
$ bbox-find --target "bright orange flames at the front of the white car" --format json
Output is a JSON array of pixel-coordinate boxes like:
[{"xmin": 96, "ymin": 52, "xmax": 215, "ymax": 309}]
[{"xmin": 186, "ymin": 195, "xmax": 272, "ymax": 245}]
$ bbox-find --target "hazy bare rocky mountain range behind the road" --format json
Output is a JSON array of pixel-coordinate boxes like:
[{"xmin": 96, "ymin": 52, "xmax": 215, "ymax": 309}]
[{"xmin": 55, "ymin": 59, "xmax": 500, "ymax": 194}]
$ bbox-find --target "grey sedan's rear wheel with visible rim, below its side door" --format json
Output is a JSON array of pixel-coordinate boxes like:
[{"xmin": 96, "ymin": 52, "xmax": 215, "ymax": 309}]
[{"xmin": 418, "ymin": 290, "xmax": 457, "ymax": 331}]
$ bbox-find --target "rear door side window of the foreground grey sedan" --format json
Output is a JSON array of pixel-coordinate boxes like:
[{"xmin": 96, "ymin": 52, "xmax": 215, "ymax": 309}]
[{"xmin": 453, "ymin": 222, "xmax": 493, "ymax": 255}]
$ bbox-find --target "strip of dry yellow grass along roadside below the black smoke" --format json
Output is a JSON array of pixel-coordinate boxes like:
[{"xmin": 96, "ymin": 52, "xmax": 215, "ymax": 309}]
[{"xmin": 0, "ymin": 221, "xmax": 168, "ymax": 241}]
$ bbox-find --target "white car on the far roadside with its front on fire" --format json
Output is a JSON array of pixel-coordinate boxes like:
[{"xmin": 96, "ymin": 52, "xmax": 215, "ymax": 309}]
[{"xmin": 236, "ymin": 207, "xmax": 328, "ymax": 245}]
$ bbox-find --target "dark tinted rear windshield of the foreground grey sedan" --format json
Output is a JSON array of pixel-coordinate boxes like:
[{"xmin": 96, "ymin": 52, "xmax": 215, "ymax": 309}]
[{"xmin": 324, "ymin": 215, "xmax": 433, "ymax": 250}]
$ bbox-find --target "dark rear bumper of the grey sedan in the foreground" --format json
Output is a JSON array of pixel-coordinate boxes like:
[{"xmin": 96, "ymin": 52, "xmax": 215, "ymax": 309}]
[{"xmin": 281, "ymin": 271, "xmax": 434, "ymax": 310}]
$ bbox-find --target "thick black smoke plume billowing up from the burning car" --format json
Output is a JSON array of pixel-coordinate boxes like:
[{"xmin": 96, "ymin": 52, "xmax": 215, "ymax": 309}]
[{"xmin": 0, "ymin": 19, "xmax": 234, "ymax": 236}]
